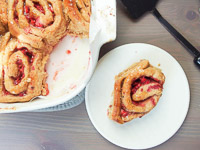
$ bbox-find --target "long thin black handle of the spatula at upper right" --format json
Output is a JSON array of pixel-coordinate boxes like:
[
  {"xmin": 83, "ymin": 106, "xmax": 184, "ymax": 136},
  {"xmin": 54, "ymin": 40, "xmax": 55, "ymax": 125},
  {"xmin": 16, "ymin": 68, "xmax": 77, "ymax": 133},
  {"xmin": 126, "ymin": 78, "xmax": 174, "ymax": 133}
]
[{"xmin": 152, "ymin": 8, "xmax": 200, "ymax": 68}]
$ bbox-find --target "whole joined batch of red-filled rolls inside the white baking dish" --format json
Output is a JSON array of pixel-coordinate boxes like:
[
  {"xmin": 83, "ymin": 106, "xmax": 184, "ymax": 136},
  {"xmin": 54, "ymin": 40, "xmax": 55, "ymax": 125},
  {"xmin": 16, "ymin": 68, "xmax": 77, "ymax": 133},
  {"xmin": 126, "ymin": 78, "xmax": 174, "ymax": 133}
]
[{"xmin": 0, "ymin": 0, "xmax": 91, "ymax": 103}]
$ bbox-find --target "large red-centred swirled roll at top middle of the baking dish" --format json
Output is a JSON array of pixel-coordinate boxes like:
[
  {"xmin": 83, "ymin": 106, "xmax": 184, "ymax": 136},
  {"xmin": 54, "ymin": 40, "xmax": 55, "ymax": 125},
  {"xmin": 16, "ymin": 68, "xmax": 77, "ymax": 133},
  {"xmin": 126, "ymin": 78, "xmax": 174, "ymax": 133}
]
[{"xmin": 8, "ymin": 0, "xmax": 66, "ymax": 49}]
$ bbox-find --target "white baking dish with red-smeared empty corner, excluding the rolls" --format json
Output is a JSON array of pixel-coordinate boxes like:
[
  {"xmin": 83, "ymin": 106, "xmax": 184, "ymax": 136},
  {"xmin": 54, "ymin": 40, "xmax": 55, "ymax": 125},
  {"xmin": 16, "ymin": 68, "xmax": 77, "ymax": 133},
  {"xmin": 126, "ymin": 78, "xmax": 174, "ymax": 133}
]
[{"xmin": 0, "ymin": 0, "xmax": 116, "ymax": 113}]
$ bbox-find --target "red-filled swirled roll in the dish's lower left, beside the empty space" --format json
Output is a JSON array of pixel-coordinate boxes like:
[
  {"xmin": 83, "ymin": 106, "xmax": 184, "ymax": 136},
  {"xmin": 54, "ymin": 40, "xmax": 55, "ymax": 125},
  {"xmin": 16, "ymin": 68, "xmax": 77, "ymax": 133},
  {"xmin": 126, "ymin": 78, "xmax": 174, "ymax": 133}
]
[{"xmin": 0, "ymin": 33, "xmax": 48, "ymax": 103}]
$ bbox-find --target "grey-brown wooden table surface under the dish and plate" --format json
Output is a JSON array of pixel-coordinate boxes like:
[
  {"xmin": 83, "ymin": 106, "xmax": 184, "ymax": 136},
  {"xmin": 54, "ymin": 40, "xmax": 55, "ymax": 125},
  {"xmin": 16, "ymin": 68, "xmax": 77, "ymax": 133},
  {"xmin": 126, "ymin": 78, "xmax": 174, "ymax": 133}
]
[{"xmin": 0, "ymin": 0, "xmax": 200, "ymax": 150}]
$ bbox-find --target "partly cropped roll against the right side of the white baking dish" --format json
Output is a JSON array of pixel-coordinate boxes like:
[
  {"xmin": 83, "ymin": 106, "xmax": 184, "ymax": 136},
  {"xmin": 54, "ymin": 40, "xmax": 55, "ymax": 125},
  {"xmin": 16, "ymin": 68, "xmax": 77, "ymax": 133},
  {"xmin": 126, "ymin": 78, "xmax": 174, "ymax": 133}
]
[{"xmin": 63, "ymin": 0, "xmax": 91, "ymax": 37}]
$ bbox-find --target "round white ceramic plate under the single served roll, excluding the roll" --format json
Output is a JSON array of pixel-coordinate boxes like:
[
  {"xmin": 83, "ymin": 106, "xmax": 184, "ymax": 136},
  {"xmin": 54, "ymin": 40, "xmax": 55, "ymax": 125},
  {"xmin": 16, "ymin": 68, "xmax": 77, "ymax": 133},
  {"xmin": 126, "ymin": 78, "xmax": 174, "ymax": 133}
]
[{"xmin": 86, "ymin": 44, "xmax": 190, "ymax": 149}]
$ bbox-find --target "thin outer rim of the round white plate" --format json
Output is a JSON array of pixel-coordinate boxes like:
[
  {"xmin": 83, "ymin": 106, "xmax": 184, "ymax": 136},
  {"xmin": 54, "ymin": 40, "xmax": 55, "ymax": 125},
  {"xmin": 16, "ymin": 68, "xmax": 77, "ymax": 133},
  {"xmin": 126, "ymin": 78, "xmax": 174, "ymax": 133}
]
[{"xmin": 85, "ymin": 43, "xmax": 191, "ymax": 149}]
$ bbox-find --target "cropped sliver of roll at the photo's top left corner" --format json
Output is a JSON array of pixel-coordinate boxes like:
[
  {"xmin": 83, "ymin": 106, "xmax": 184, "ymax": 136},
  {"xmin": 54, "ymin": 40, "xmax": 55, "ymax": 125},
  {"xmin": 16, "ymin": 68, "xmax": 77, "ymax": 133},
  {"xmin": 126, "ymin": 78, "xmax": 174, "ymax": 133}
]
[{"xmin": 0, "ymin": 0, "xmax": 8, "ymax": 35}]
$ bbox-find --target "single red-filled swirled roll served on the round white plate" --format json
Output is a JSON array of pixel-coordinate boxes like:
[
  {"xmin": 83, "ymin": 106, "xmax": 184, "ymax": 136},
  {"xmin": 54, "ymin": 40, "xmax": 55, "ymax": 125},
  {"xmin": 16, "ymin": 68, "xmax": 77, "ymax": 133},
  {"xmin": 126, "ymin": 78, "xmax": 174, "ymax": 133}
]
[{"xmin": 108, "ymin": 60, "xmax": 165, "ymax": 124}]
